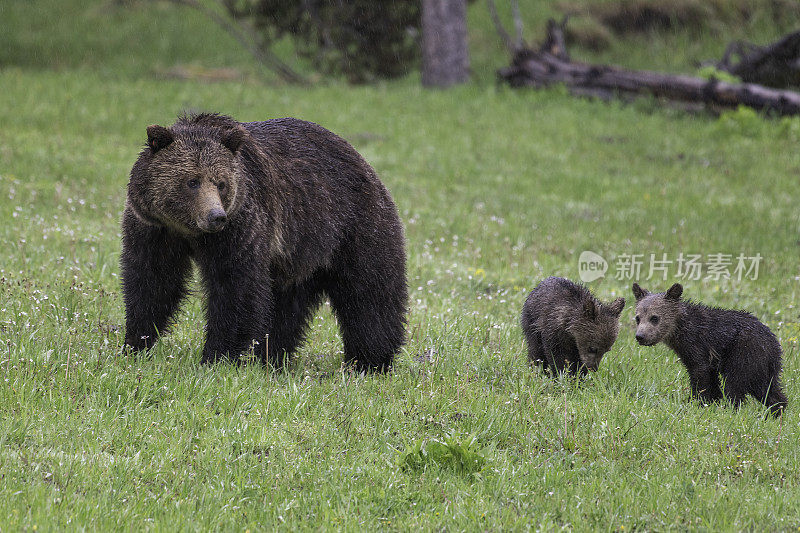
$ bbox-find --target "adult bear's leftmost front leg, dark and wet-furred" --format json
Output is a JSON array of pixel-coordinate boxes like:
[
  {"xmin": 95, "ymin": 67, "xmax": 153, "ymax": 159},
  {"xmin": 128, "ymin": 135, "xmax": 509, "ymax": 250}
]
[{"xmin": 120, "ymin": 209, "xmax": 192, "ymax": 351}]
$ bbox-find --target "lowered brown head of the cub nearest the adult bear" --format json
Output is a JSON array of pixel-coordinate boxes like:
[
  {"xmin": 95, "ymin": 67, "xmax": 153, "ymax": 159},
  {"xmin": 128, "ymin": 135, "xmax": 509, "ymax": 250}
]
[{"xmin": 570, "ymin": 298, "xmax": 625, "ymax": 370}]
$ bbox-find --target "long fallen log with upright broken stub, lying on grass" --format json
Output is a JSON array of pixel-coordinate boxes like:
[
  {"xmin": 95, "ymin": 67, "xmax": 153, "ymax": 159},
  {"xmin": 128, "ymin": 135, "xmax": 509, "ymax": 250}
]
[{"xmin": 497, "ymin": 22, "xmax": 800, "ymax": 115}]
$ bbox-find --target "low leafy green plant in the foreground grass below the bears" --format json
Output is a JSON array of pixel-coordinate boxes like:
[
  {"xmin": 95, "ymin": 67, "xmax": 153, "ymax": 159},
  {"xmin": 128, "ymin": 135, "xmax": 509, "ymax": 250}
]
[{"xmin": 397, "ymin": 435, "xmax": 486, "ymax": 475}]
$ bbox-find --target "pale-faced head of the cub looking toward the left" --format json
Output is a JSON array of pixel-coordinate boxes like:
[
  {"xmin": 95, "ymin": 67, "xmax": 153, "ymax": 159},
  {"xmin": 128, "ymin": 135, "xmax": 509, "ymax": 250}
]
[{"xmin": 633, "ymin": 283, "xmax": 683, "ymax": 346}]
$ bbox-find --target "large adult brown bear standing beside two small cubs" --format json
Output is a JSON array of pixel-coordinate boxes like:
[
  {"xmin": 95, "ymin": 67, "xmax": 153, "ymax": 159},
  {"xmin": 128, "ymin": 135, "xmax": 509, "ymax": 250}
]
[{"xmin": 121, "ymin": 114, "xmax": 408, "ymax": 370}]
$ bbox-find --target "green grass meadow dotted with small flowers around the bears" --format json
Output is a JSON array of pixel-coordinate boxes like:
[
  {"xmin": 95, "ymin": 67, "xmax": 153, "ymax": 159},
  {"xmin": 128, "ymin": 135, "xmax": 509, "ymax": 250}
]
[{"xmin": 0, "ymin": 2, "xmax": 800, "ymax": 531}]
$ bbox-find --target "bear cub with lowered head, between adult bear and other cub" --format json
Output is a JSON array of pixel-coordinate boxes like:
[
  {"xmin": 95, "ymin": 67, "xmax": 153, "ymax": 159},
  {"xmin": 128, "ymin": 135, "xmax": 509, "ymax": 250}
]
[{"xmin": 521, "ymin": 277, "xmax": 625, "ymax": 376}]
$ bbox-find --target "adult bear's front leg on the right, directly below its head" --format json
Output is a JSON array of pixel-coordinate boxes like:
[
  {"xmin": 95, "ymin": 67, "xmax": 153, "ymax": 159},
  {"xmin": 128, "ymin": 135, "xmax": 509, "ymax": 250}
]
[{"xmin": 198, "ymin": 242, "xmax": 272, "ymax": 364}]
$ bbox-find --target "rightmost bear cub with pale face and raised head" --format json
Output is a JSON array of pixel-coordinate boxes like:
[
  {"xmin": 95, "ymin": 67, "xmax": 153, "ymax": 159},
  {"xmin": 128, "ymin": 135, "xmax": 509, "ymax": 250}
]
[{"xmin": 633, "ymin": 283, "xmax": 786, "ymax": 416}]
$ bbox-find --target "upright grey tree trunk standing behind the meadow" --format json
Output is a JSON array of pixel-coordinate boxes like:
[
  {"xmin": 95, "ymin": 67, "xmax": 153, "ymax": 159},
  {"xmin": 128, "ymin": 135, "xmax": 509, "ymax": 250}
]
[{"xmin": 422, "ymin": 0, "xmax": 469, "ymax": 87}]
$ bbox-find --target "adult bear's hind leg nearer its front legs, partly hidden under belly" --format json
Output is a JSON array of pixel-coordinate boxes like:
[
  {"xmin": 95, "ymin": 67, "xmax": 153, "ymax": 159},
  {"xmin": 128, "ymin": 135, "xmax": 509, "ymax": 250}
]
[{"xmin": 260, "ymin": 279, "xmax": 322, "ymax": 368}]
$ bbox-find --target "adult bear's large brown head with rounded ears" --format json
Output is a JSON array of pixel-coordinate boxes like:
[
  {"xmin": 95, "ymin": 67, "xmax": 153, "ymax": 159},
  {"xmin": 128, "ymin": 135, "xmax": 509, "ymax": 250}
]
[{"xmin": 128, "ymin": 117, "xmax": 248, "ymax": 236}]
